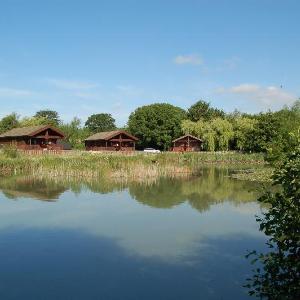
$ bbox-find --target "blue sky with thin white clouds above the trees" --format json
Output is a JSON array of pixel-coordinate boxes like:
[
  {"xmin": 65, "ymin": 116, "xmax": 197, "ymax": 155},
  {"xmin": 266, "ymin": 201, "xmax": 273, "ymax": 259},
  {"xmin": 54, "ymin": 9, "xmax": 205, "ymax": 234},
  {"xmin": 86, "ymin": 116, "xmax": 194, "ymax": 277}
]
[{"xmin": 0, "ymin": 0, "xmax": 300, "ymax": 125}]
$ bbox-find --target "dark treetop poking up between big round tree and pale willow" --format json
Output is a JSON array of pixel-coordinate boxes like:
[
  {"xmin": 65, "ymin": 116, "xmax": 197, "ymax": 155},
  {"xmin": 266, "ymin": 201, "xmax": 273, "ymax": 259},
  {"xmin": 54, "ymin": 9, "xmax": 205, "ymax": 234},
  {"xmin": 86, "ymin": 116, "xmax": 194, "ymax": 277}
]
[{"xmin": 187, "ymin": 100, "xmax": 225, "ymax": 122}]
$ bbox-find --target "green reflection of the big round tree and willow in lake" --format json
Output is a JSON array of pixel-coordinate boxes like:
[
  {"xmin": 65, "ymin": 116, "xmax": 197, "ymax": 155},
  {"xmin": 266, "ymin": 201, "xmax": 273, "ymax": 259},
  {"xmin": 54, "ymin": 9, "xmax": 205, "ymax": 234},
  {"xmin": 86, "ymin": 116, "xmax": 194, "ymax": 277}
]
[{"xmin": 129, "ymin": 168, "xmax": 258, "ymax": 212}]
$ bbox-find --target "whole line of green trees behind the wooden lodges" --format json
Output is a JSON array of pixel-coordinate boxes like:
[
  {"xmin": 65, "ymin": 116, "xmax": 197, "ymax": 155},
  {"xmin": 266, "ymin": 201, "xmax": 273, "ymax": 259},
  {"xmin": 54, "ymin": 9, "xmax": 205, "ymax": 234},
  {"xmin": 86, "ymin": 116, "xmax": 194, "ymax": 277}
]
[{"xmin": 0, "ymin": 100, "xmax": 300, "ymax": 157}]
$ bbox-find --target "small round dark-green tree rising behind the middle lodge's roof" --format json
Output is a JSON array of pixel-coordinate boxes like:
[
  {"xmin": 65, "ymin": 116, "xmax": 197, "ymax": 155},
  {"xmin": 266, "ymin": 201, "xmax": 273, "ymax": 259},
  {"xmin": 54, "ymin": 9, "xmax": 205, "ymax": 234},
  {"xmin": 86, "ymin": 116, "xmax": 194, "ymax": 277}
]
[{"xmin": 85, "ymin": 114, "xmax": 116, "ymax": 133}]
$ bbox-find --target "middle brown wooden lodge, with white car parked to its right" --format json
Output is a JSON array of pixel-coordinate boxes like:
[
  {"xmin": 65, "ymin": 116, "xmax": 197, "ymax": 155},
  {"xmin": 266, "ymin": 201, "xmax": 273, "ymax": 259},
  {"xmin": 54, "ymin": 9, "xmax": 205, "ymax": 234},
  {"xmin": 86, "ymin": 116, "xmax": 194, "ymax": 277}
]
[{"xmin": 85, "ymin": 130, "xmax": 138, "ymax": 151}]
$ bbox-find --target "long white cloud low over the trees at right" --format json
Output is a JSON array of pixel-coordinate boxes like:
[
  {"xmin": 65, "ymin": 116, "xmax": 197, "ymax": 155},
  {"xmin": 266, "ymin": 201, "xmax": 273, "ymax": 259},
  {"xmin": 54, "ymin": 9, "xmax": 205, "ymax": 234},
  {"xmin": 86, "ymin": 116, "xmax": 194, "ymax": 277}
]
[{"xmin": 217, "ymin": 83, "xmax": 297, "ymax": 109}]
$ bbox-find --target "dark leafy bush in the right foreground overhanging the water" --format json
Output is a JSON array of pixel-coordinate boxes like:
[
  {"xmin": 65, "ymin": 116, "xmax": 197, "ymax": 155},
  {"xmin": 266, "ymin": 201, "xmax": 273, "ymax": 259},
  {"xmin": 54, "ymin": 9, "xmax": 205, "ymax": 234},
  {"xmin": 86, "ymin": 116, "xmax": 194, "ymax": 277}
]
[{"xmin": 246, "ymin": 141, "xmax": 300, "ymax": 300}]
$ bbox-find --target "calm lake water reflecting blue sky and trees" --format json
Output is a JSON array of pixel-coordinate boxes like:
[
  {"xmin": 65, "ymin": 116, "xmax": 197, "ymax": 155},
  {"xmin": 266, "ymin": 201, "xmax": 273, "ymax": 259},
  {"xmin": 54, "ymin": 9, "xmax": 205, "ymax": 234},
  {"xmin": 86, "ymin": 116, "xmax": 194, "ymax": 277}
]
[{"xmin": 0, "ymin": 169, "xmax": 264, "ymax": 300}]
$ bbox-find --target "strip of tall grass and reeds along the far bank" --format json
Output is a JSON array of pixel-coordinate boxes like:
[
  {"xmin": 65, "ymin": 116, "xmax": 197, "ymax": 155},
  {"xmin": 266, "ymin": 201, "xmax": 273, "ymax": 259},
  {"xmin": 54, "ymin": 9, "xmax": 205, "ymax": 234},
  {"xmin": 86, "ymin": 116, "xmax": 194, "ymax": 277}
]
[{"xmin": 0, "ymin": 151, "xmax": 264, "ymax": 180}]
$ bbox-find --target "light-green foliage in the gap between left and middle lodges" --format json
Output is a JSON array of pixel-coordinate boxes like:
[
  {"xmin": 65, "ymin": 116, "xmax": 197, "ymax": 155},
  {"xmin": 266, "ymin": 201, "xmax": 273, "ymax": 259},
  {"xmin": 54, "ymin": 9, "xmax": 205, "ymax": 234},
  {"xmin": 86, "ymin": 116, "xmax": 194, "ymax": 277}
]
[{"xmin": 60, "ymin": 117, "xmax": 90, "ymax": 149}]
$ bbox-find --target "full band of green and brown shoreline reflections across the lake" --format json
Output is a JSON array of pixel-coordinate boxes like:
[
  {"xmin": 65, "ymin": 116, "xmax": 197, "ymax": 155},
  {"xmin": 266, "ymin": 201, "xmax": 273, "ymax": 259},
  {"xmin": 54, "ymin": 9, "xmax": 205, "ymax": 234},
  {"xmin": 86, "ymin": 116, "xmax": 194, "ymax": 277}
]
[{"xmin": 0, "ymin": 167, "xmax": 257, "ymax": 212}]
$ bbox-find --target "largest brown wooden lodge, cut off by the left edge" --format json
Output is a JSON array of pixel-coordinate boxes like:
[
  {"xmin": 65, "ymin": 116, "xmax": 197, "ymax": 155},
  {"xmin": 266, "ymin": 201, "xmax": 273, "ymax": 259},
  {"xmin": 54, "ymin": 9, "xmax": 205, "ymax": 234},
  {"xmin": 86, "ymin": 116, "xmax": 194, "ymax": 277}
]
[{"xmin": 0, "ymin": 125, "xmax": 64, "ymax": 150}]
